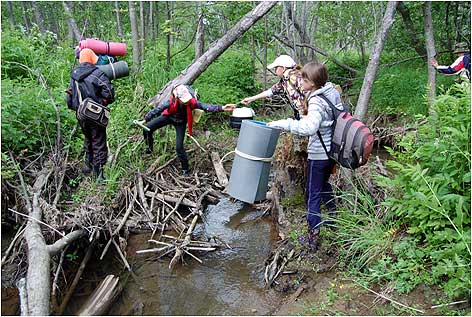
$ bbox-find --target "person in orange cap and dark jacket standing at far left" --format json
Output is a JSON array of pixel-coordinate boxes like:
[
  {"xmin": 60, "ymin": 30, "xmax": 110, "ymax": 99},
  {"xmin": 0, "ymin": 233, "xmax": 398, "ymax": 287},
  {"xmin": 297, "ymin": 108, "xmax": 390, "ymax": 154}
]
[{"xmin": 66, "ymin": 48, "xmax": 115, "ymax": 180}]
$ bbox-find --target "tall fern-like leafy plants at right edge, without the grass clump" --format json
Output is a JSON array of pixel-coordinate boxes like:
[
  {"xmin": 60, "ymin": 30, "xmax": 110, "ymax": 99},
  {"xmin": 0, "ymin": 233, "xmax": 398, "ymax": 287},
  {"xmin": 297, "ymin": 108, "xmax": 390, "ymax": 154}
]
[{"xmin": 376, "ymin": 84, "xmax": 471, "ymax": 297}]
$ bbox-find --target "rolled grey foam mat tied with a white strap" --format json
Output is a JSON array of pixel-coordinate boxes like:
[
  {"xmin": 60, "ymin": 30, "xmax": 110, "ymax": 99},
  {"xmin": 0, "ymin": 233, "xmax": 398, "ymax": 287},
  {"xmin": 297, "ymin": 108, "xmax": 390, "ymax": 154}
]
[{"xmin": 228, "ymin": 120, "xmax": 280, "ymax": 204}]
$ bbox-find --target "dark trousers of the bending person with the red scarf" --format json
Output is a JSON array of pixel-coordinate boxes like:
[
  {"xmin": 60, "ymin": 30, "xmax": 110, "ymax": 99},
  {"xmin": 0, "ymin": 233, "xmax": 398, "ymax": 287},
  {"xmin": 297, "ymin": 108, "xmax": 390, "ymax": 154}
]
[{"xmin": 143, "ymin": 115, "xmax": 189, "ymax": 170}]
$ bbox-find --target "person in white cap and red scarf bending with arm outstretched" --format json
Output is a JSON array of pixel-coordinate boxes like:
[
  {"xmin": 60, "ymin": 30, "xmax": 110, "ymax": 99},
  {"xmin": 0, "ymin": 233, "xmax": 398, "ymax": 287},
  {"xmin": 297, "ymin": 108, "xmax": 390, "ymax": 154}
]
[{"xmin": 141, "ymin": 85, "xmax": 236, "ymax": 176}]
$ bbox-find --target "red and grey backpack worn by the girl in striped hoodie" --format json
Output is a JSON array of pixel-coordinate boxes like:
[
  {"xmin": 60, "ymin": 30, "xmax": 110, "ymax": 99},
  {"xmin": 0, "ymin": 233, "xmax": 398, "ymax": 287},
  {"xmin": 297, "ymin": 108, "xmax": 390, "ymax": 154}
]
[{"xmin": 317, "ymin": 94, "xmax": 374, "ymax": 169}]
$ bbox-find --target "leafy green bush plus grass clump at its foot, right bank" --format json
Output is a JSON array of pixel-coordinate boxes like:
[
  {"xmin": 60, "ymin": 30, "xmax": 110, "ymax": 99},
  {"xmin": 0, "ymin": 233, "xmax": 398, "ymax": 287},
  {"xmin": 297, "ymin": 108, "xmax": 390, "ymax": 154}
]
[{"xmin": 334, "ymin": 84, "xmax": 471, "ymax": 299}]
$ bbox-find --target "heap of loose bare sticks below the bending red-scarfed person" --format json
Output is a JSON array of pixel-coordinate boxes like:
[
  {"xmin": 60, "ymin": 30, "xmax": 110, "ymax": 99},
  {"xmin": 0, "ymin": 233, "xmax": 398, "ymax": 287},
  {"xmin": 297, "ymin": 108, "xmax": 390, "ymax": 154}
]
[{"xmin": 97, "ymin": 153, "xmax": 226, "ymax": 270}]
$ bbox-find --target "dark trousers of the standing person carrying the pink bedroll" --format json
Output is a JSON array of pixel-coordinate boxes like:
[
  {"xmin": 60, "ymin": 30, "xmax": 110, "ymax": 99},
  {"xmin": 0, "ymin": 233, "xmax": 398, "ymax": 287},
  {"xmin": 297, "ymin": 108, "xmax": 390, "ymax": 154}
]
[{"xmin": 79, "ymin": 120, "xmax": 108, "ymax": 168}]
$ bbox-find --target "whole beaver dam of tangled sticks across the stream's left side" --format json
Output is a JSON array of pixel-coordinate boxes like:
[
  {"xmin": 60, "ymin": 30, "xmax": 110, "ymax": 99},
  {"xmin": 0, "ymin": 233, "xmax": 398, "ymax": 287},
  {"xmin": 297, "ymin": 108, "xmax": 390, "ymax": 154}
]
[{"xmin": 2, "ymin": 144, "xmax": 282, "ymax": 314}]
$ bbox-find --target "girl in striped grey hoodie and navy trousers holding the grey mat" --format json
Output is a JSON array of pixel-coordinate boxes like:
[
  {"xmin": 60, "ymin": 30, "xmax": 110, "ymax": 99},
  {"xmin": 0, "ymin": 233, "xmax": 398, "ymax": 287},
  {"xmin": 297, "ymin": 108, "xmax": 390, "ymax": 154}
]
[{"xmin": 268, "ymin": 62, "xmax": 342, "ymax": 251}]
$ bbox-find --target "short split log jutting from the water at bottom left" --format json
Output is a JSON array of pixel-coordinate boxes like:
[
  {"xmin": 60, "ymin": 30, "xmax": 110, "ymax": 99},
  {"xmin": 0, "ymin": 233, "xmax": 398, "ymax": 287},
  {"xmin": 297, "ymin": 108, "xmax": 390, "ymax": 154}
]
[{"xmin": 77, "ymin": 275, "xmax": 122, "ymax": 316}]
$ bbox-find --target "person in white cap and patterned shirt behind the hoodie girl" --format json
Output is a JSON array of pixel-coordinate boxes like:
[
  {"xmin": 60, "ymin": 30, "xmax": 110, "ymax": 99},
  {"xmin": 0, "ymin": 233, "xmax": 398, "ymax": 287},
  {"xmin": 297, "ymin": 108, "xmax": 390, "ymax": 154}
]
[{"xmin": 241, "ymin": 55, "xmax": 305, "ymax": 120}]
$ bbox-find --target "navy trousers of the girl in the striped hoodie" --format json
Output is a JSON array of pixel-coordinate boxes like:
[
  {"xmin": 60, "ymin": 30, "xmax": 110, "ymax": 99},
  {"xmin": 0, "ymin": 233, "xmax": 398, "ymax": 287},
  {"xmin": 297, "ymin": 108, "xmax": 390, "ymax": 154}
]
[{"xmin": 306, "ymin": 160, "xmax": 336, "ymax": 230}]
